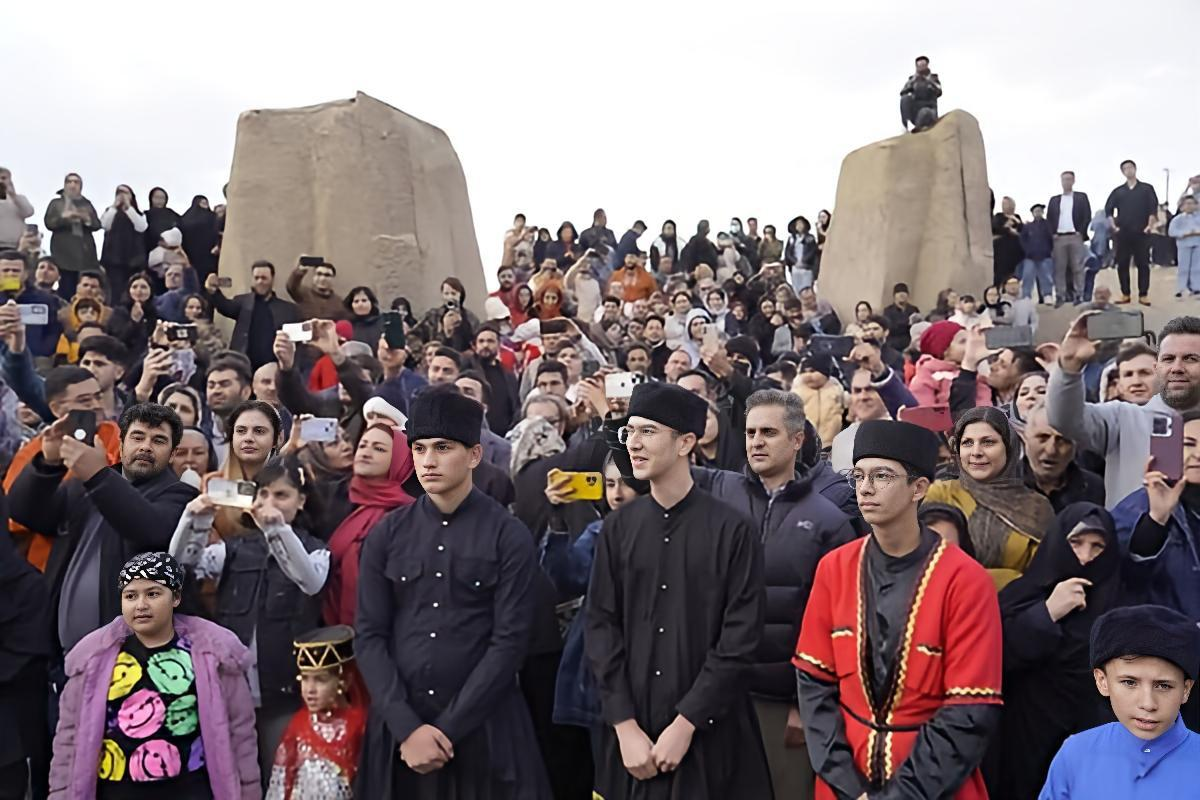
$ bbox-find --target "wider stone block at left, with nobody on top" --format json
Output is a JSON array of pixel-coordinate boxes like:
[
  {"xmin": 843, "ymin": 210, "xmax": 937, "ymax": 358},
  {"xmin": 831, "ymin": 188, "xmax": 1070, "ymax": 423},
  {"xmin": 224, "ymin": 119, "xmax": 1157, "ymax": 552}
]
[{"xmin": 220, "ymin": 92, "xmax": 487, "ymax": 314}]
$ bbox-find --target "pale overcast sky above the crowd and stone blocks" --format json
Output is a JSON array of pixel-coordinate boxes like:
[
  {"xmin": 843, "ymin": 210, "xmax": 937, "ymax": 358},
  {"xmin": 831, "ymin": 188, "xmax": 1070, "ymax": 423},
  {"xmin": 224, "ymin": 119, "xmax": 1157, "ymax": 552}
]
[{"xmin": 0, "ymin": 0, "xmax": 1200, "ymax": 279}]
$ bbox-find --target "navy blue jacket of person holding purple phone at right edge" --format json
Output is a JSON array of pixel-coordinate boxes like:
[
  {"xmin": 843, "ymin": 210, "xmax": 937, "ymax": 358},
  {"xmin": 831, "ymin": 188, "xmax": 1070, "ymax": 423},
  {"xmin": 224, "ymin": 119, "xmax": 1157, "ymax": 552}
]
[{"xmin": 1112, "ymin": 489, "xmax": 1200, "ymax": 621}]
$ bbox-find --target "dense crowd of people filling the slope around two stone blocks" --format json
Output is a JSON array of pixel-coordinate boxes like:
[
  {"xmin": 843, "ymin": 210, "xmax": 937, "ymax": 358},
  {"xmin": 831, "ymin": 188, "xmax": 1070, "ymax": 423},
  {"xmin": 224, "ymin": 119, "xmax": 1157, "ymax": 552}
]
[{"xmin": 0, "ymin": 162, "xmax": 1200, "ymax": 800}]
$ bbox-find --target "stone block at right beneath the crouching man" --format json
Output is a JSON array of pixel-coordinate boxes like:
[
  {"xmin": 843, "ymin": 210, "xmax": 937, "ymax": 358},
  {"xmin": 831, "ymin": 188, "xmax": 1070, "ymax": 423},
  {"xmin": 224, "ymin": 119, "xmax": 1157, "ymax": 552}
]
[{"xmin": 818, "ymin": 110, "xmax": 992, "ymax": 320}]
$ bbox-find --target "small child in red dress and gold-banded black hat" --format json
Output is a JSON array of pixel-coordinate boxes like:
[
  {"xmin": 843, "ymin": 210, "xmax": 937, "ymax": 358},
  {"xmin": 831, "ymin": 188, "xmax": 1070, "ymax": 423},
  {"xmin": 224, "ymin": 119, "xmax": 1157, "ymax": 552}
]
[{"xmin": 266, "ymin": 625, "xmax": 367, "ymax": 800}]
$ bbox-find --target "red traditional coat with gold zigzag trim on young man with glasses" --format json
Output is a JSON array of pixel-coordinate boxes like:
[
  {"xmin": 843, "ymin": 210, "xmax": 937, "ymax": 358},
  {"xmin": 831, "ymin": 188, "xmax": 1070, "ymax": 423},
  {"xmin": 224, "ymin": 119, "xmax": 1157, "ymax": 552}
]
[{"xmin": 792, "ymin": 537, "xmax": 1003, "ymax": 800}]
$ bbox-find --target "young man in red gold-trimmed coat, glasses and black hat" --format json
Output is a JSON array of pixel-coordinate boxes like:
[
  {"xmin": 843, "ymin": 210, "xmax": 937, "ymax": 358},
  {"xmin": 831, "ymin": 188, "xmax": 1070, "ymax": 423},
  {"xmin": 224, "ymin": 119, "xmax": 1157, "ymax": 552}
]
[{"xmin": 792, "ymin": 420, "xmax": 1002, "ymax": 800}]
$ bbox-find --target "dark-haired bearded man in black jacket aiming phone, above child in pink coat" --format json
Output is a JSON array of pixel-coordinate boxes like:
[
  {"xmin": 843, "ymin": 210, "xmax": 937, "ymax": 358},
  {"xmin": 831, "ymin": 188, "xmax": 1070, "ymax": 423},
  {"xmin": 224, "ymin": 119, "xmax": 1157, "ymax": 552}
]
[{"xmin": 10, "ymin": 403, "xmax": 196, "ymax": 652}]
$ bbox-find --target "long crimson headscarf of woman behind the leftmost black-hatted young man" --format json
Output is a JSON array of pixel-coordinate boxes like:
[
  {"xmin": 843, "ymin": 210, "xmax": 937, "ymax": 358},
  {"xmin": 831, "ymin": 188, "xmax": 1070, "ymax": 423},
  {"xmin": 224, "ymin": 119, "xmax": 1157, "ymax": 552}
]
[{"xmin": 324, "ymin": 425, "xmax": 415, "ymax": 625}]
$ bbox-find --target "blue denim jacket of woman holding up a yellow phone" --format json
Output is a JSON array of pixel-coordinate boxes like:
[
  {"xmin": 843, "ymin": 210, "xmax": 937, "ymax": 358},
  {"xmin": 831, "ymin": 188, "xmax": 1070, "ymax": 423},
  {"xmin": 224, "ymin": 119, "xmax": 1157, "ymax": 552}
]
[{"xmin": 541, "ymin": 519, "xmax": 604, "ymax": 728}]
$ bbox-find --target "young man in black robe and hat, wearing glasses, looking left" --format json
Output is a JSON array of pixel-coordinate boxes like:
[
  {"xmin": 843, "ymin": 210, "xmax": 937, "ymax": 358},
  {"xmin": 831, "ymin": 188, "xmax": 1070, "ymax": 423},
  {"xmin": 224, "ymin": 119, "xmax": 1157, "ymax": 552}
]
[{"xmin": 586, "ymin": 383, "xmax": 773, "ymax": 800}]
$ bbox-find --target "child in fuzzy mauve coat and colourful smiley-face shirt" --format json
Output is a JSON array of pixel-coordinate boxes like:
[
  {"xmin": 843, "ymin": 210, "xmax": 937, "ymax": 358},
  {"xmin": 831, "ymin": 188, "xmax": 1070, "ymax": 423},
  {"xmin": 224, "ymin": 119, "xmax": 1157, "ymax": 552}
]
[{"xmin": 49, "ymin": 553, "xmax": 260, "ymax": 800}]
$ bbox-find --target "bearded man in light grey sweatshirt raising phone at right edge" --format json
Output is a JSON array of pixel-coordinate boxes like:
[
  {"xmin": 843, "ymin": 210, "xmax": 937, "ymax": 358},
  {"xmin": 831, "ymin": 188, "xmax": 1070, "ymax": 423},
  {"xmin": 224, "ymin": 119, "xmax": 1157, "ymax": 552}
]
[{"xmin": 1046, "ymin": 312, "xmax": 1200, "ymax": 509}]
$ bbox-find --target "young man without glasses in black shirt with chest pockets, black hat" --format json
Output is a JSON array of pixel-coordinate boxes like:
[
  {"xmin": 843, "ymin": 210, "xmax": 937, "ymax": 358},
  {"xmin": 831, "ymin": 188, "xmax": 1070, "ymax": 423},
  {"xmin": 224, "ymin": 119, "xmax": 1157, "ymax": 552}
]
[{"xmin": 354, "ymin": 389, "xmax": 550, "ymax": 800}]
